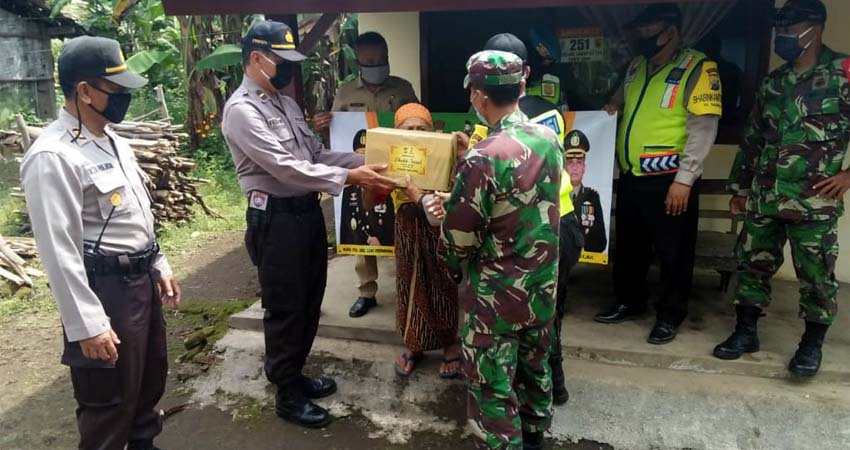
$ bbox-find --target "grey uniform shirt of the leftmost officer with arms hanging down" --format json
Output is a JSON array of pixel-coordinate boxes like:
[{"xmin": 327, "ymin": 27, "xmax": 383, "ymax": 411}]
[{"xmin": 21, "ymin": 109, "xmax": 171, "ymax": 342}]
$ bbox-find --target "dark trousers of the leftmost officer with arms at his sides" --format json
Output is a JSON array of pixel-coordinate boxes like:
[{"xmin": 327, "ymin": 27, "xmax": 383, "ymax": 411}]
[{"xmin": 62, "ymin": 273, "xmax": 168, "ymax": 450}]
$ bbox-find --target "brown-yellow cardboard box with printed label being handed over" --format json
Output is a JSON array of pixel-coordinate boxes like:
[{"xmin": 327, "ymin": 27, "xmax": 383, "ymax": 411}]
[{"xmin": 366, "ymin": 128, "xmax": 457, "ymax": 191}]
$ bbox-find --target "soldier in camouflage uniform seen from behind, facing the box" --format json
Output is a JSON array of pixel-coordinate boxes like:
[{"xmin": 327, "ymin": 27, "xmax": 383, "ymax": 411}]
[{"xmin": 442, "ymin": 50, "xmax": 563, "ymax": 450}]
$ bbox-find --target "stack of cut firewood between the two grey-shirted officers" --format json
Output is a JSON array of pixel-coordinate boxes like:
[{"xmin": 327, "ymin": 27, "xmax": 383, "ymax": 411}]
[{"xmin": 110, "ymin": 121, "xmax": 218, "ymax": 224}]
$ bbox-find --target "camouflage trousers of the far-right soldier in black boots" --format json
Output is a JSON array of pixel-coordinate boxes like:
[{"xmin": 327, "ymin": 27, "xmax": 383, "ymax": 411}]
[{"xmin": 735, "ymin": 214, "xmax": 838, "ymax": 325}]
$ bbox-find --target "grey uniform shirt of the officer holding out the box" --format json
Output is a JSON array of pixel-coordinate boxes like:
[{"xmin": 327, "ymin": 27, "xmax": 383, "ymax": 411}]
[{"xmin": 222, "ymin": 76, "xmax": 363, "ymax": 197}]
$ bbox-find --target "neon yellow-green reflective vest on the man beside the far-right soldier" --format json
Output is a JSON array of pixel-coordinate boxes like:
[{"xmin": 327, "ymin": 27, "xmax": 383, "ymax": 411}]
[{"xmin": 617, "ymin": 49, "xmax": 720, "ymax": 176}]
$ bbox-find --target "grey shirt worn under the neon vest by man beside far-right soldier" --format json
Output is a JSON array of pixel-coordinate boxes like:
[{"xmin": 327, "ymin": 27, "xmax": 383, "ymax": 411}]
[{"xmin": 611, "ymin": 56, "xmax": 720, "ymax": 186}]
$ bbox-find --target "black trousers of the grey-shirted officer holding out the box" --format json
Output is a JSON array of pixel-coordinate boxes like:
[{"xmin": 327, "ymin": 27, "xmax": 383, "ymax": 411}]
[{"xmin": 245, "ymin": 196, "xmax": 328, "ymax": 387}]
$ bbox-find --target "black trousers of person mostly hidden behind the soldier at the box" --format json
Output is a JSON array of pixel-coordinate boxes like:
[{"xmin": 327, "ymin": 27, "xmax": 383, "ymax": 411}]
[{"xmin": 549, "ymin": 213, "xmax": 584, "ymax": 370}]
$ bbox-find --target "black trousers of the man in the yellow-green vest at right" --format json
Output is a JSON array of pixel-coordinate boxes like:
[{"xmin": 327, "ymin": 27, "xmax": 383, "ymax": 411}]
[{"xmin": 614, "ymin": 174, "xmax": 699, "ymax": 326}]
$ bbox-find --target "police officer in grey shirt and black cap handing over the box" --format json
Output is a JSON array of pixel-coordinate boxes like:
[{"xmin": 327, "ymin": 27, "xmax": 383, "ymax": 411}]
[{"xmin": 222, "ymin": 21, "xmax": 396, "ymax": 427}]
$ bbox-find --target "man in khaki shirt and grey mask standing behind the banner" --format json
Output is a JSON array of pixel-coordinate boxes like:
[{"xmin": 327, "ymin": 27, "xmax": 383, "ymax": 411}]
[{"xmin": 313, "ymin": 32, "xmax": 419, "ymax": 317}]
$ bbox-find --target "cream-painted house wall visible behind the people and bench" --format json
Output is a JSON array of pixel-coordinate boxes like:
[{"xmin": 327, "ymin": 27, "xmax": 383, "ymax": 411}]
[{"xmin": 360, "ymin": 0, "xmax": 850, "ymax": 283}]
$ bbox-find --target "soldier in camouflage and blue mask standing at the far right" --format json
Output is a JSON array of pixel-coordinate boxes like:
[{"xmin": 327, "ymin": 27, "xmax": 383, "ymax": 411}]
[{"xmin": 714, "ymin": 0, "xmax": 850, "ymax": 376}]
